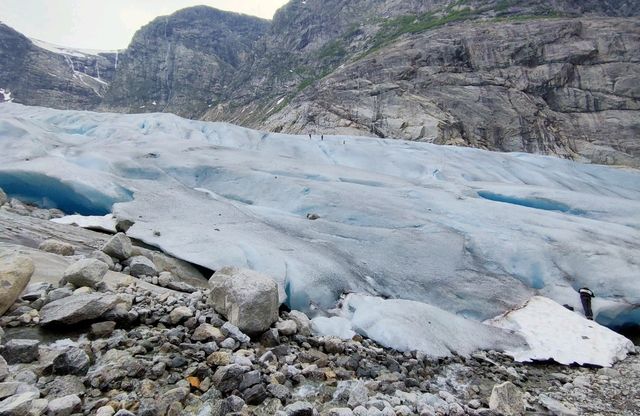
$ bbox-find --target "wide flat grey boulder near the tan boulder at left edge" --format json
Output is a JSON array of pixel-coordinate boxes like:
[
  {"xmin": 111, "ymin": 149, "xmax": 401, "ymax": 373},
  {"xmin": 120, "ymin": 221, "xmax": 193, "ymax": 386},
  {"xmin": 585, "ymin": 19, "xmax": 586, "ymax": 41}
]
[{"xmin": 40, "ymin": 293, "xmax": 118, "ymax": 326}]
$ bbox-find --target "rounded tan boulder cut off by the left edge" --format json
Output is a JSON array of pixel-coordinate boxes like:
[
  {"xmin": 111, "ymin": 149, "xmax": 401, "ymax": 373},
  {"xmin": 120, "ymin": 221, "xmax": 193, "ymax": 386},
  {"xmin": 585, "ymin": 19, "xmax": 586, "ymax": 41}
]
[{"xmin": 0, "ymin": 254, "xmax": 35, "ymax": 316}]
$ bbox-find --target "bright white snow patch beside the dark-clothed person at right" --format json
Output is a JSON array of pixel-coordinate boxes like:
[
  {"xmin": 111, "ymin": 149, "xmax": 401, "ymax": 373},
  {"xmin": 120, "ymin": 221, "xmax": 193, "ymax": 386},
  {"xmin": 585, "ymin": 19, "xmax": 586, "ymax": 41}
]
[{"xmin": 488, "ymin": 296, "xmax": 635, "ymax": 367}]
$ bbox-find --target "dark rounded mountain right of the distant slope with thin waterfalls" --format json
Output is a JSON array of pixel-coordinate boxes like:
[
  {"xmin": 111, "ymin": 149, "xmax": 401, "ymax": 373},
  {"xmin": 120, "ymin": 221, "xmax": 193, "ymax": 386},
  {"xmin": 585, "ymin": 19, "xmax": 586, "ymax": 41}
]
[{"xmin": 101, "ymin": 6, "xmax": 269, "ymax": 118}]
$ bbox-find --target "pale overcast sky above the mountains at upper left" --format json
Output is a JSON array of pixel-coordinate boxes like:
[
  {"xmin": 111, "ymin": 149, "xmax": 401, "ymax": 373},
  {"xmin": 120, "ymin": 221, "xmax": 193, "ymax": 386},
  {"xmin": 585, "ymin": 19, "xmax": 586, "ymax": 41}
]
[{"xmin": 0, "ymin": 0, "xmax": 288, "ymax": 49}]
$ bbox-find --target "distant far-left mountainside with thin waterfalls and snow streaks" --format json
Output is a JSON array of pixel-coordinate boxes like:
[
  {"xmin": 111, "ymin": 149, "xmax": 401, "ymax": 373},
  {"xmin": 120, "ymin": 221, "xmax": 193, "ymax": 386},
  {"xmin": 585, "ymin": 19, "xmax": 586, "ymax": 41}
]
[{"xmin": 0, "ymin": 23, "xmax": 116, "ymax": 109}]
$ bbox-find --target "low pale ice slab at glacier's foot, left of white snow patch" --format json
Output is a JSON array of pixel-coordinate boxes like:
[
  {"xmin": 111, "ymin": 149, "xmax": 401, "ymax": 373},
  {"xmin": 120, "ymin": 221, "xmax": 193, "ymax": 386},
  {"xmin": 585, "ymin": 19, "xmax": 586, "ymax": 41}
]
[{"xmin": 312, "ymin": 294, "xmax": 526, "ymax": 358}]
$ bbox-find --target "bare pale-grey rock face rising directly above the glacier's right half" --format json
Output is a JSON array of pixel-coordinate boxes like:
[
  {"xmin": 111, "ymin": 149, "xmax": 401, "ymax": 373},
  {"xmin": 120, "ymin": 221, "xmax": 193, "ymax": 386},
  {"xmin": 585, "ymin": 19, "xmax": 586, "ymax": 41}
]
[{"xmin": 265, "ymin": 18, "xmax": 640, "ymax": 166}]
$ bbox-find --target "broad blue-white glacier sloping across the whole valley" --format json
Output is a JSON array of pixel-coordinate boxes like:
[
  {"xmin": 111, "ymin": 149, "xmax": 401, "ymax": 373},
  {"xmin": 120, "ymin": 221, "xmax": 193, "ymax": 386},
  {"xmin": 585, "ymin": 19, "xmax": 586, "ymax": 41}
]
[{"xmin": 0, "ymin": 103, "xmax": 640, "ymax": 334}]
